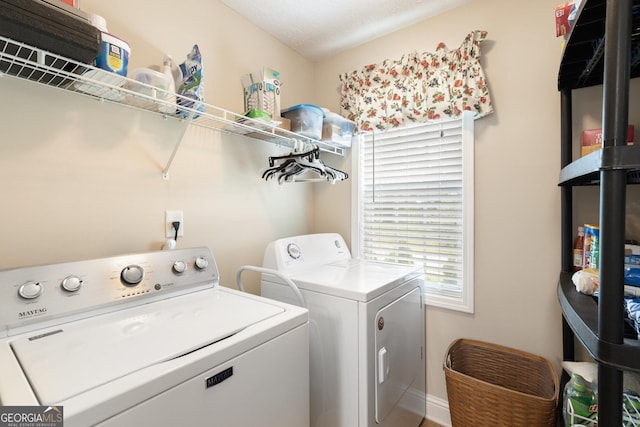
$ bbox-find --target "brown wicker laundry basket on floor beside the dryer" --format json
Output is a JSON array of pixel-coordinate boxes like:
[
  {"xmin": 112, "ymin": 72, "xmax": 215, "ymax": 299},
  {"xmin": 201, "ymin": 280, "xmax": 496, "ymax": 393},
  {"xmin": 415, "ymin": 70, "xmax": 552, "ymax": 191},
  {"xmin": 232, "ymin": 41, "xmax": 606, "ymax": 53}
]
[{"xmin": 444, "ymin": 339, "xmax": 559, "ymax": 427}]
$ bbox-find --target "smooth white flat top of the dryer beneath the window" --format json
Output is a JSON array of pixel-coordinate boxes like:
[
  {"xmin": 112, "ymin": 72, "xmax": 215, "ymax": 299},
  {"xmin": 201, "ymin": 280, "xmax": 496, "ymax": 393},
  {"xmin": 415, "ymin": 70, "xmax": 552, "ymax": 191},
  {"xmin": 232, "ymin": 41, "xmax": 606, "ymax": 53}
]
[{"xmin": 284, "ymin": 259, "xmax": 422, "ymax": 302}]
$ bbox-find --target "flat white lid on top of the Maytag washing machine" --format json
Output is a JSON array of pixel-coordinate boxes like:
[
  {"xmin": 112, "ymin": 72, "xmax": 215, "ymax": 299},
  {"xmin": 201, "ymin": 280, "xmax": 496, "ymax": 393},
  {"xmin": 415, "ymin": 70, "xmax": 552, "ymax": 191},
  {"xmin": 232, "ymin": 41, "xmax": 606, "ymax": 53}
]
[{"xmin": 11, "ymin": 288, "xmax": 285, "ymax": 405}]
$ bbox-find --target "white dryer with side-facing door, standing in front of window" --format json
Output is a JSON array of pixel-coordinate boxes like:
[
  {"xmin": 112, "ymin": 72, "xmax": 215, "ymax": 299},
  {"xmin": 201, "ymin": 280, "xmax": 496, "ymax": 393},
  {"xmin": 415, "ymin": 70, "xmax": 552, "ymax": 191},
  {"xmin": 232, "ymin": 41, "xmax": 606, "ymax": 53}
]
[{"xmin": 261, "ymin": 233, "xmax": 426, "ymax": 427}]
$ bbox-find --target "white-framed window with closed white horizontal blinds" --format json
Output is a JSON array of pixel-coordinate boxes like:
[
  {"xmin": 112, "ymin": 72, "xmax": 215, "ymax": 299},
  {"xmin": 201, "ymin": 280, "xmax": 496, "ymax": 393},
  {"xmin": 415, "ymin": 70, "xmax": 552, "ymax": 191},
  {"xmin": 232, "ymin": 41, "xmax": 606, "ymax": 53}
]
[{"xmin": 354, "ymin": 114, "xmax": 474, "ymax": 312}]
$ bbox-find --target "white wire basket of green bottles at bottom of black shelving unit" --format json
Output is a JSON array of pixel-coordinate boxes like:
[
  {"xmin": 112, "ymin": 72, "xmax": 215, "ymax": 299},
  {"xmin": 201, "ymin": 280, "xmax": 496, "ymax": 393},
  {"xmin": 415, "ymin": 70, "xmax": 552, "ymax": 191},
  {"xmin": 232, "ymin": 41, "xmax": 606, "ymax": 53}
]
[{"xmin": 562, "ymin": 362, "xmax": 640, "ymax": 427}]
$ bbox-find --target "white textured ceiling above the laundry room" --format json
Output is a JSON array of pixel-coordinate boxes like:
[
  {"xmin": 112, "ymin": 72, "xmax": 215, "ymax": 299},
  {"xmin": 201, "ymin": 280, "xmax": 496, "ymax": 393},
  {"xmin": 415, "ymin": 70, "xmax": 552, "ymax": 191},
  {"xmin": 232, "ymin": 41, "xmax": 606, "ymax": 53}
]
[{"xmin": 220, "ymin": 0, "xmax": 472, "ymax": 61}]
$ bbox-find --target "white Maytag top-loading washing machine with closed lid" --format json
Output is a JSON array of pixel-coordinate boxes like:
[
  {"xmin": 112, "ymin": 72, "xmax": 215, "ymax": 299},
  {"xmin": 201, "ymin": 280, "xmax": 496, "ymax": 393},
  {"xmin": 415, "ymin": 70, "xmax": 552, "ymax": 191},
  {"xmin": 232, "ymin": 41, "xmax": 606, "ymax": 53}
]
[{"xmin": 0, "ymin": 248, "xmax": 309, "ymax": 427}]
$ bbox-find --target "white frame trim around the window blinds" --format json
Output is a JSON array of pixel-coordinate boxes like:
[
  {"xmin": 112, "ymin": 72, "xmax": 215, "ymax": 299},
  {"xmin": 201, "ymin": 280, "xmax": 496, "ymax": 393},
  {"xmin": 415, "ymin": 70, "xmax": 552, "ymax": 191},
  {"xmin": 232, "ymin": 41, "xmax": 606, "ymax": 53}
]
[{"xmin": 351, "ymin": 111, "xmax": 475, "ymax": 314}]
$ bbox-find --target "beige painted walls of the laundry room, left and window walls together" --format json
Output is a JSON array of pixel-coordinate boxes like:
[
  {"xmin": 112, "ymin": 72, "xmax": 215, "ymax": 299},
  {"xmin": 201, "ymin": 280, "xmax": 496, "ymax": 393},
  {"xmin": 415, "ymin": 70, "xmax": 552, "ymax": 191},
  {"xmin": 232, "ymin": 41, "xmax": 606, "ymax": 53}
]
[{"xmin": 0, "ymin": 0, "xmax": 608, "ymax": 422}]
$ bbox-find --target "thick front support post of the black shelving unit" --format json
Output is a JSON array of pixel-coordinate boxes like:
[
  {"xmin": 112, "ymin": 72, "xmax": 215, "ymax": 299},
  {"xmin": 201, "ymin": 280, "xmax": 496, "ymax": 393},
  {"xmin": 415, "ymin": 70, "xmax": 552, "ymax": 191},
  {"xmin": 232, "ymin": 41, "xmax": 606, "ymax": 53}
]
[{"xmin": 598, "ymin": 0, "xmax": 633, "ymax": 426}]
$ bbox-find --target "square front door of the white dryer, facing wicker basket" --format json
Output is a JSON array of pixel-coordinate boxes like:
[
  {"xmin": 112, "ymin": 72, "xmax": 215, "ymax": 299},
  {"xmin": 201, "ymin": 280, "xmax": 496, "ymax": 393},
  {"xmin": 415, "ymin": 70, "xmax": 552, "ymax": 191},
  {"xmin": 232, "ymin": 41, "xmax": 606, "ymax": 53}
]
[{"xmin": 375, "ymin": 288, "xmax": 424, "ymax": 423}]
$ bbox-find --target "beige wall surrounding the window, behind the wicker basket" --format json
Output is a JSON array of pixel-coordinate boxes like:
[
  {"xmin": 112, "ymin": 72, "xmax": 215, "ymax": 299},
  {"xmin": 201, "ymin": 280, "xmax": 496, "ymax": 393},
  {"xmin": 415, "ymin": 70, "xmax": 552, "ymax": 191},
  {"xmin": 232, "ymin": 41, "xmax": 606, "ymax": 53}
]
[{"xmin": 315, "ymin": 0, "xmax": 562, "ymax": 416}]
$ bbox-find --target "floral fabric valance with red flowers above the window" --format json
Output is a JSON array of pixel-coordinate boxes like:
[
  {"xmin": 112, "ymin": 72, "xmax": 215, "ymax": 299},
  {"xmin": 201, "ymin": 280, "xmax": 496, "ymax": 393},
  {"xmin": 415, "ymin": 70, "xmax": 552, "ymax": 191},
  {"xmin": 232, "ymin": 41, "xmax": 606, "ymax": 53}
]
[{"xmin": 340, "ymin": 31, "xmax": 493, "ymax": 131}]
